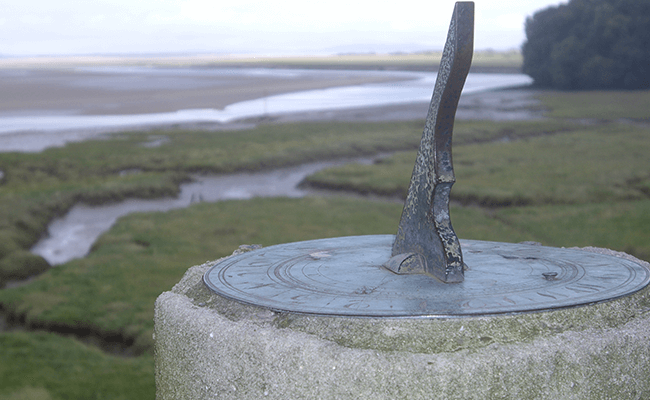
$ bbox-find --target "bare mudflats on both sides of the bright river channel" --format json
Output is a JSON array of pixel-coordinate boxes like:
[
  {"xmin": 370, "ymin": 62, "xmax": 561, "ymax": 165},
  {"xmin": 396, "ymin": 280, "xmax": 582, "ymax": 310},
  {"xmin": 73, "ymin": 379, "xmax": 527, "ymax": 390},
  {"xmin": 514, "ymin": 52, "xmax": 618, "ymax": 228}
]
[{"xmin": 0, "ymin": 60, "xmax": 542, "ymax": 152}]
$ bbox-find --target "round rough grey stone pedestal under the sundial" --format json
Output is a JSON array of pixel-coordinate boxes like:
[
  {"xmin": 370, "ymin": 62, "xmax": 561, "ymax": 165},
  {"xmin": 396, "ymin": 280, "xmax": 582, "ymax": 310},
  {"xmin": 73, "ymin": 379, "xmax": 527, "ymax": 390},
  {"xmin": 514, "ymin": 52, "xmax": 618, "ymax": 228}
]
[{"xmin": 155, "ymin": 248, "xmax": 650, "ymax": 400}]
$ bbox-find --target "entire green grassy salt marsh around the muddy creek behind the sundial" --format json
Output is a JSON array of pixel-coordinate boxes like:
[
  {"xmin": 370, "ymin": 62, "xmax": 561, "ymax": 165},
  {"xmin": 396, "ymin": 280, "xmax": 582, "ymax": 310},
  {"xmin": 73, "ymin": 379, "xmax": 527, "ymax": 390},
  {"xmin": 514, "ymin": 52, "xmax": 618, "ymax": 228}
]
[{"xmin": 0, "ymin": 86, "xmax": 650, "ymax": 400}]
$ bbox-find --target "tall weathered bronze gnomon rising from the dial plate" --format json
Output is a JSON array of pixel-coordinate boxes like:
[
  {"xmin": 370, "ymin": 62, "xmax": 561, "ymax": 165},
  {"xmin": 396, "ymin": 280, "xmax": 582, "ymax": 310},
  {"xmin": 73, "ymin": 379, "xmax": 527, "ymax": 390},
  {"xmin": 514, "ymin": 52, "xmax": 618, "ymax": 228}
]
[{"xmin": 386, "ymin": 2, "xmax": 474, "ymax": 283}]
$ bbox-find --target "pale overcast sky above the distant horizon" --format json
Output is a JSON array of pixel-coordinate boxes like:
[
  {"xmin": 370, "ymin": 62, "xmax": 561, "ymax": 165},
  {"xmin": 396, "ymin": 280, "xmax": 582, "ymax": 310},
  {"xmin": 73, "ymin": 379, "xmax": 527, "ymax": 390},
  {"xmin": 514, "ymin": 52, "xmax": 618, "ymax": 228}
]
[{"xmin": 0, "ymin": 0, "xmax": 561, "ymax": 56}]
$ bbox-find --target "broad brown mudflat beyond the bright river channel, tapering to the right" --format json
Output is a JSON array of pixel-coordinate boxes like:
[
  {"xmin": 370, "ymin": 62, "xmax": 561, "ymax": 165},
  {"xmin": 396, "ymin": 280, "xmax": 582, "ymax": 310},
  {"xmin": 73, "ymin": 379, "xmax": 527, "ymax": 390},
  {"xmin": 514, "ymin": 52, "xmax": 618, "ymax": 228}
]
[{"xmin": 0, "ymin": 68, "xmax": 408, "ymax": 115}]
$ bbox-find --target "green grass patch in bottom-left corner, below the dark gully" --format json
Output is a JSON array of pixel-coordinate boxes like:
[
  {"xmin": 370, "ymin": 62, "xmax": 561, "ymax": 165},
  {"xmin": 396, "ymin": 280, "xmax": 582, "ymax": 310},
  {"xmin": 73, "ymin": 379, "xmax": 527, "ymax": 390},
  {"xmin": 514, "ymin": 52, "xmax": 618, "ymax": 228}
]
[{"xmin": 0, "ymin": 332, "xmax": 155, "ymax": 400}]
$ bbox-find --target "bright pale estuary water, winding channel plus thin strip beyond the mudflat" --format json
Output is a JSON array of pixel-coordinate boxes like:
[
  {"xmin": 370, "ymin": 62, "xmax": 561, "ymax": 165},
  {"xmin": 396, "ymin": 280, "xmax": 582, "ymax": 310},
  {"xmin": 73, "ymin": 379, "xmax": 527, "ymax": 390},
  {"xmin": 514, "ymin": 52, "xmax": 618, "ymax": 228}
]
[{"xmin": 0, "ymin": 67, "xmax": 532, "ymax": 134}]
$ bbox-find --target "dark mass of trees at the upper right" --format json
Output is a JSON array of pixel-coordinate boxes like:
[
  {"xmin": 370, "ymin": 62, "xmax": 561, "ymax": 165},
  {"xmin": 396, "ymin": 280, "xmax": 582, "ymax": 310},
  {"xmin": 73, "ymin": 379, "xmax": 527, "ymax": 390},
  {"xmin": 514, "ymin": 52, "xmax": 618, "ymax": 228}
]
[{"xmin": 522, "ymin": 0, "xmax": 650, "ymax": 89}]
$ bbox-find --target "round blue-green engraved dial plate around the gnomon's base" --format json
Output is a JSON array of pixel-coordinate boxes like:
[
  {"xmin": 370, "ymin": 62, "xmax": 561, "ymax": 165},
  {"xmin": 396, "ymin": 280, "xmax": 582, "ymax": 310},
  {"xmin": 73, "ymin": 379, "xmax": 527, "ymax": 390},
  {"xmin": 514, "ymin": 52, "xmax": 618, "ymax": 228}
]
[{"xmin": 204, "ymin": 235, "xmax": 650, "ymax": 317}]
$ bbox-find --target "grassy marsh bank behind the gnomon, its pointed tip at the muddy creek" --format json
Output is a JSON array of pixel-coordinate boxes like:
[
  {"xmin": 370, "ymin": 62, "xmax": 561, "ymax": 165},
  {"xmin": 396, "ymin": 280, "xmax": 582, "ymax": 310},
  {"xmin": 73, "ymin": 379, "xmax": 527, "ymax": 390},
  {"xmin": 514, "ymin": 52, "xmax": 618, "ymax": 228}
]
[{"xmin": 307, "ymin": 122, "xmax": 650, "ymax": 207}]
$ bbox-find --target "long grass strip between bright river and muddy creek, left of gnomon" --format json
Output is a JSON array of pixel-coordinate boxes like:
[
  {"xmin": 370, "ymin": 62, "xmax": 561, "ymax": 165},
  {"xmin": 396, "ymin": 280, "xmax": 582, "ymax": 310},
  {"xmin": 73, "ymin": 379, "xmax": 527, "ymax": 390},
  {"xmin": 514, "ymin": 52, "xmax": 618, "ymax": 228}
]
[{"xmin": 0, "ymin": 119, "xmax": 418, "ymax": 182}]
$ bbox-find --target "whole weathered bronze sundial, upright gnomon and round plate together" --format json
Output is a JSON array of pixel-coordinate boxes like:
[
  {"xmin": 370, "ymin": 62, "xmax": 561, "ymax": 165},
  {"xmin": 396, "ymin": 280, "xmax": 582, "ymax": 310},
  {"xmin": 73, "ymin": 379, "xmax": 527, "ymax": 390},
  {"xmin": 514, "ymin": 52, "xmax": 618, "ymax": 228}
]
[{"xmin": 203, "ymin": 2, "xmax": 650, "ymax": 318}]
